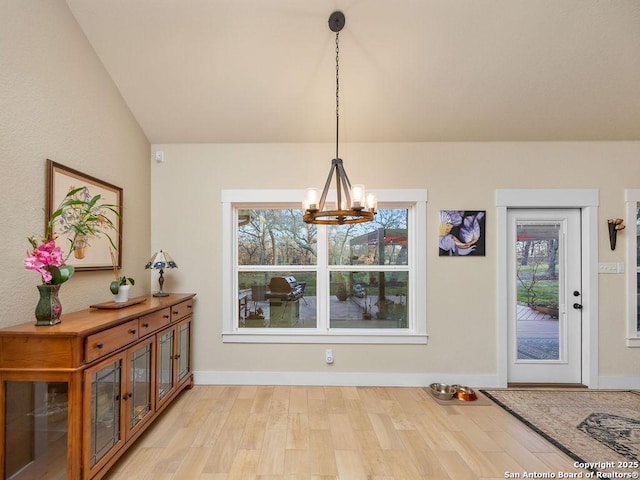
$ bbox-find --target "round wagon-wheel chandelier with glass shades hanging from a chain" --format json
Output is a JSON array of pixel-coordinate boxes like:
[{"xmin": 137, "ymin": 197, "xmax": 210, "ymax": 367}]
[{"xmin": 302, "ymin": 12, "xmax": 377, "ymax": 225}]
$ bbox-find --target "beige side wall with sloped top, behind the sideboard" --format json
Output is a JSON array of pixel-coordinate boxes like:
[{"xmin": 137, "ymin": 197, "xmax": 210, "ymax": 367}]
[{"xmin": 0, "ymin": 0, "xmax": 150, "ymax": 327}]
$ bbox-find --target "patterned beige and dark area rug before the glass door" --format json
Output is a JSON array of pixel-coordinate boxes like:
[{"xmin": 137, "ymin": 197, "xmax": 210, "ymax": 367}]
[{"xmin": 481, "ymin": 389, "xmax": 640, "ymax": 472}]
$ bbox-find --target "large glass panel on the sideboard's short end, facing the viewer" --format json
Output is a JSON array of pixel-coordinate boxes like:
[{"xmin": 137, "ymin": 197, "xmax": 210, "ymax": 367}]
[{"xmin": 3, "ymin": 381, "xmax": 69, "ymax": 480}]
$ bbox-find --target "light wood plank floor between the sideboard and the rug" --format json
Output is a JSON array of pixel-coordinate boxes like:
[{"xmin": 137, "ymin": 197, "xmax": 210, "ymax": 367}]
[{"xmin": 105, "ymin": 386, "xmax": 579, "ymax": 480}]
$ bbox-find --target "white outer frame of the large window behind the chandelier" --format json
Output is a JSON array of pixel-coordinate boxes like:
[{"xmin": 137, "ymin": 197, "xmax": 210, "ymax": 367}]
[{"xmin": 220, "ymin": 189, "xmax": 428, "ymax": 344}]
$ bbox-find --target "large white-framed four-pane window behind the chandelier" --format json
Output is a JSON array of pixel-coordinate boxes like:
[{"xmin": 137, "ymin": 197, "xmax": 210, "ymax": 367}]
[{"xmin": 222, "ymin": 190, "xmax": 426, "ymax": 343}]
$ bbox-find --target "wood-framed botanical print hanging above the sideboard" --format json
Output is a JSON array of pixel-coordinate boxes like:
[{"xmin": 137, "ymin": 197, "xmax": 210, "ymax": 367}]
[{"xmin": 45, "ymin": 160, "xmax": 122, "ymax": 270}]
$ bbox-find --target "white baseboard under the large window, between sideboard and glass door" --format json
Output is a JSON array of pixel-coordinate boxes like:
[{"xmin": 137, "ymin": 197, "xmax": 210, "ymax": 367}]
[{"xmin": 194, "ymin": 371, "xmax": 501, "ymax": 388}]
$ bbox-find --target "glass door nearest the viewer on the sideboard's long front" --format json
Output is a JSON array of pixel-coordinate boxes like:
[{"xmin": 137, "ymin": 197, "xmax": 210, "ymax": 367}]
[{"xmin": 89, "ymin": 357, "xmax": 123, "ymax": 467}]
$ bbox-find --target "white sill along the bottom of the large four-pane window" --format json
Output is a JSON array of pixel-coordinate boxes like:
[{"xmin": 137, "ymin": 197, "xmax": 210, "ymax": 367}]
[{"xmin": 222, "ymin": 329, "xmax": 428, "ymax": 345}]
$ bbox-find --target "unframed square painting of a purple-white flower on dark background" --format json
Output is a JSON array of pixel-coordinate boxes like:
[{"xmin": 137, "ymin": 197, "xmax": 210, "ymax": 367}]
[{"xmin": 438, "ymin": 210, "xmax": 487, "ymax": 257}]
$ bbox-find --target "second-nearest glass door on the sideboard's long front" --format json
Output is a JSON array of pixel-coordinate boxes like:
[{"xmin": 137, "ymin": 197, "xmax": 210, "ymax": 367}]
[{"xmin": 124, "ymin": 340, "xmax": 153, "ymax": 432}]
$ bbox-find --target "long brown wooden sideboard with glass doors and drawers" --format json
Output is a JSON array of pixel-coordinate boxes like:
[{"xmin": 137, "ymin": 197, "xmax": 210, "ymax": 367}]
[{"xmin": 0, "ymin": 293, "xmax": 195, "ymax": 480}]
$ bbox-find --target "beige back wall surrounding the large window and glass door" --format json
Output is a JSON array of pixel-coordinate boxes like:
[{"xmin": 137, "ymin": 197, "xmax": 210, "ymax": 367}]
[{"xmin": 151, "ymin": 142, "xmax": 640, "ymax": 386}]
